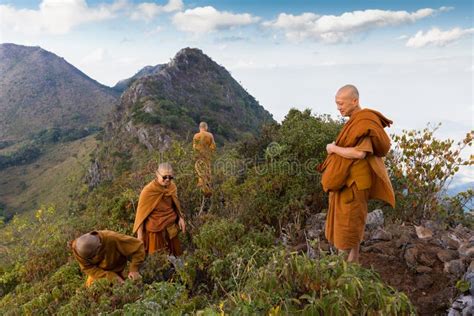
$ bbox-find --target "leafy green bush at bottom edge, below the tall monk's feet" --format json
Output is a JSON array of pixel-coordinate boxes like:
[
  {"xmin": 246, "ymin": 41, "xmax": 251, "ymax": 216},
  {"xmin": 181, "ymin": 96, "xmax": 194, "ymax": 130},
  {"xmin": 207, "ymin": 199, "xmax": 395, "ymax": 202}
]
[{"xmin": 216, "ymin": 252, "xmax": 415, "ymax": 315}]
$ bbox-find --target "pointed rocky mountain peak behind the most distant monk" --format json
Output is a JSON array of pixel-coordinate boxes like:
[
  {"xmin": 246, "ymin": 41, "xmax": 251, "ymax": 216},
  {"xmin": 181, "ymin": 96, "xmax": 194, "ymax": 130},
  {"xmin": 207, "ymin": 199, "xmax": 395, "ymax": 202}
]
[{"xmin": 103, "ymin": 48, "xmax": 274, "ymax": 150}]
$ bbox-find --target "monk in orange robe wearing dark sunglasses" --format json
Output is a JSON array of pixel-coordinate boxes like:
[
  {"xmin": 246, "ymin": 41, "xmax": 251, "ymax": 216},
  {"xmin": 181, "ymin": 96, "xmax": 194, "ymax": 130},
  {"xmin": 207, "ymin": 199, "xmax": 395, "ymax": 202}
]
[{"xmin": 133, "ymin": 163, "xmax": 186, "ymax": 256}]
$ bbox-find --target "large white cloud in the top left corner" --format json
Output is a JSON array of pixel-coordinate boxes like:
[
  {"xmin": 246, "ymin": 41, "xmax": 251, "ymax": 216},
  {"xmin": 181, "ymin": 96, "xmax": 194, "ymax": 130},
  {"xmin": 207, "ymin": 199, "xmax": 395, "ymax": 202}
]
[{"xmin": 0, "ymin": 0, "xmax": 125, "ymax": 35}]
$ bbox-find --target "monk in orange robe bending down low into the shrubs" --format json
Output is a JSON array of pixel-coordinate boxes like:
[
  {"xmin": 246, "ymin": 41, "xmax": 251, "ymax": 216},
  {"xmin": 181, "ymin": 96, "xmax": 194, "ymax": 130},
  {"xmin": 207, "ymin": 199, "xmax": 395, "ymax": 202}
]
[{"xmin": 71, "ymin": 230, "xmax": 145, "ymax": 287}]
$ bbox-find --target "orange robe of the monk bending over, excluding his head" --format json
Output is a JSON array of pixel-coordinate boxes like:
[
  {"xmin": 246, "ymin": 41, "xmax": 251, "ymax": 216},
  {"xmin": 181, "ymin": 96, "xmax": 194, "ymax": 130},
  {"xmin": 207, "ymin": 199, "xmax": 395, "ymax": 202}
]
[{"xmin": 72, "ymin": 230, "xmax": 145, "ymax": 286}]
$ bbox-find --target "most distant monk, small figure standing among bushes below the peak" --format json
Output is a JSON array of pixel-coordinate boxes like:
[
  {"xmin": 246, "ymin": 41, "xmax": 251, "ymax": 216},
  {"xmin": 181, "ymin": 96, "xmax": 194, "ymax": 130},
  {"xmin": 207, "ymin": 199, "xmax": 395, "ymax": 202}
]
[{"xmin": 193, "ymin": 122, "xmax": 216, "ymax": 197}]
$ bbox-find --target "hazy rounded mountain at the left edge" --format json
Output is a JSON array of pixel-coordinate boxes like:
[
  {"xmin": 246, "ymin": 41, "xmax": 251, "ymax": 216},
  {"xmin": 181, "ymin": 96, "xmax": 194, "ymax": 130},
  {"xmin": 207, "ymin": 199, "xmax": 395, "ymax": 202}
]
[{"xmin": 0, "ymin": 44, "xmax": 118, "ymax": 142}]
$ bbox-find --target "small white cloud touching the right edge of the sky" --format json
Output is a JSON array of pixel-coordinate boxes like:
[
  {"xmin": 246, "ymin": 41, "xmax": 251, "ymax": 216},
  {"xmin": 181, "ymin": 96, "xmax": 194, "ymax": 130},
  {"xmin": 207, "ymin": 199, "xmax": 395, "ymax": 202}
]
[{"xmin": 406, "ymin": 27, "xmax": 474, "ymax": 48}]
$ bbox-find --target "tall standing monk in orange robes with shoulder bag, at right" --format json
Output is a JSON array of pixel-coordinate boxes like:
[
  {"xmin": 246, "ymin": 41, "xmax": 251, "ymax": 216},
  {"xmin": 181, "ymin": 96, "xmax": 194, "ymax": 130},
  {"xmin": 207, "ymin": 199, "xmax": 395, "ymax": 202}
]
[{"xmin": 319, "ymin": 85, "xmax": 395, "ymax": 262}]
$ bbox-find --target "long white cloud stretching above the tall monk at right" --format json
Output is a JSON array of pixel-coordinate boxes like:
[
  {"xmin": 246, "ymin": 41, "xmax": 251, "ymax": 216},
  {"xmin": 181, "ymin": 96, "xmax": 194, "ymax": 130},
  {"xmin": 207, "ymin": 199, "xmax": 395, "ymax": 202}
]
[{"xmin": 263, "ymin": 7, "xmax": 451, "ymax": 43}]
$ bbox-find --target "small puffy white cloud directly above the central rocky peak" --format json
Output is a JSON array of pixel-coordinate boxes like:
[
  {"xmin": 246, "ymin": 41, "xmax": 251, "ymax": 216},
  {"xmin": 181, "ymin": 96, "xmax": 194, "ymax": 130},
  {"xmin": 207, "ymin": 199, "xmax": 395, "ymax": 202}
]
[{"xmin": 173, "ymin": 6, "xmax": 260, "ymax": 34}]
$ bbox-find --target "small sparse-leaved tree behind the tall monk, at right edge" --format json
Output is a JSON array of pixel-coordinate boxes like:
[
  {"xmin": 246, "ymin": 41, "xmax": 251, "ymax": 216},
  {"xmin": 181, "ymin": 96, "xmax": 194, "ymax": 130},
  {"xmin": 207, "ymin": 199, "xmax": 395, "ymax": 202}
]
[{"xmin": 387, "ymin": 124, "xmax": 474, "ymax": 220}]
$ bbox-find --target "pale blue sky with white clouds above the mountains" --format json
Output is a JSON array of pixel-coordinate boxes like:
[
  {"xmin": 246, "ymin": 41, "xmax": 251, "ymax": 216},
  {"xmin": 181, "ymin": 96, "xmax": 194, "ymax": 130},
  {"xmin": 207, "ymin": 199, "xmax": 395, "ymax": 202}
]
[{"xmin": 0, "ymin": 0, "xmax": 474, "ymax": 188}]
